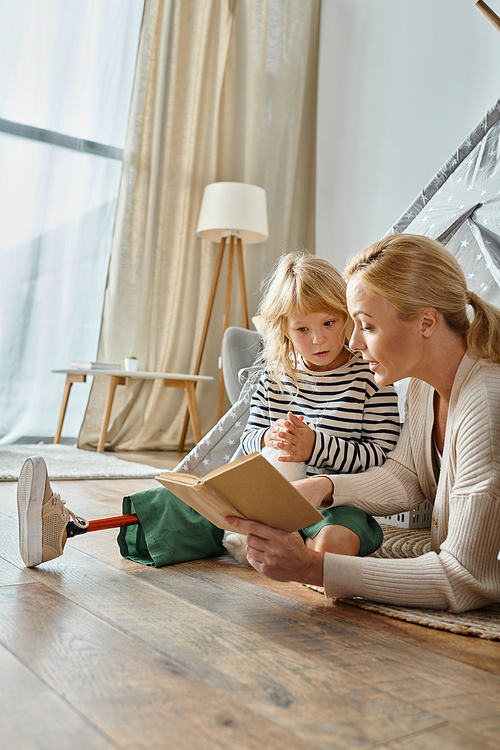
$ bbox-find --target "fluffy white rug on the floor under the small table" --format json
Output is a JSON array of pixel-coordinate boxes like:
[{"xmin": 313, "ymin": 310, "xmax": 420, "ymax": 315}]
[{"xmin": 0, "ymin": 443, "xmax": 165, "ymax": 482}]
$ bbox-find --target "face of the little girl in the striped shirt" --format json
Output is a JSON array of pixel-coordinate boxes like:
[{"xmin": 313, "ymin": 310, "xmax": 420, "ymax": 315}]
[{"xmin": 286, "ymin": 311, "xmax": 350, "ymax": 372}]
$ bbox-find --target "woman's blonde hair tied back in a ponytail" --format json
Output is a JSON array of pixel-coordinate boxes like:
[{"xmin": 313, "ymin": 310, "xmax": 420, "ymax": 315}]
[{"xmin": 344, "ymin": 234, "xmax": 500, "ymax": 363}]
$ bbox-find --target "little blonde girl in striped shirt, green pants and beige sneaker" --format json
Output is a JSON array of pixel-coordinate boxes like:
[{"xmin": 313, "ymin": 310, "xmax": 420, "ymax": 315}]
[{"xmin": 18, "ymin": 254, "xmax": 399, "ymax": 567}]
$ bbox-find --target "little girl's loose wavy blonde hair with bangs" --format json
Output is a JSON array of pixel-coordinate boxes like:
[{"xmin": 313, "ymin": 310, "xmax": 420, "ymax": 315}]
[{"xmin": 259, "ymin": 252, "xmax": 353, "ymax": 390}]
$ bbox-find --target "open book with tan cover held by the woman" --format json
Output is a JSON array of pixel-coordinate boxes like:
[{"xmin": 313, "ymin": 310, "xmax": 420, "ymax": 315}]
[{"xmin": 156, "ymin": 453, "xmax": 323, "ymax": 531}]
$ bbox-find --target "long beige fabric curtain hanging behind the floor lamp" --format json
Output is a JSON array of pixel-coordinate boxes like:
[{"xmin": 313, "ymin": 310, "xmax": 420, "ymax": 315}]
[{"xmin": 78, "ymin": 0, "xmax": 320, "ymax": 450}]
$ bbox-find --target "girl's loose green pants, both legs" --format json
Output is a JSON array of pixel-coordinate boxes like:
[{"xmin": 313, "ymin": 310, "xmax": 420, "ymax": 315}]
[{"xmin": 118, "ymin": 487, "xmax": 383, "ymax": 568}]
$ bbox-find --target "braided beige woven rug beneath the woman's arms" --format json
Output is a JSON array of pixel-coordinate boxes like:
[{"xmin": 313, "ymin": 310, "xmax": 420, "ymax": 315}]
[{"xmin": 309, "ymin": 524, "xmax": 500, "ymax": 641}]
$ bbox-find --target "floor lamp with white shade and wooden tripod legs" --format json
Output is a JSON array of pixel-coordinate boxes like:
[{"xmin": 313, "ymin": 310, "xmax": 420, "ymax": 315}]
[{"xmin": 179, "ymin": 182, "xmax": 269, "ymax": 451}]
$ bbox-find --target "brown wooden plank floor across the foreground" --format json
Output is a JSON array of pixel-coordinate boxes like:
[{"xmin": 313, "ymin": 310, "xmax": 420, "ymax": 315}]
[{"xmin": 0, "ymin": 454, "xmax": 500, "ymax": 750}]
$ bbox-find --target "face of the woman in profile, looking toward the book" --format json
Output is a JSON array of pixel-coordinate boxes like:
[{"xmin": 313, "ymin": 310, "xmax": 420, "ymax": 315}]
[{"xmin": 347, "ymin": 276, "xmax": 423, "ymax": 386}]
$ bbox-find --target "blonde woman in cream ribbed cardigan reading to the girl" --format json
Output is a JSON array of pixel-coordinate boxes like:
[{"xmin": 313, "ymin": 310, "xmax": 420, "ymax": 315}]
[{"xmin": 229, "ymin": 235, "xmax": 500, "ymax": 612}]
